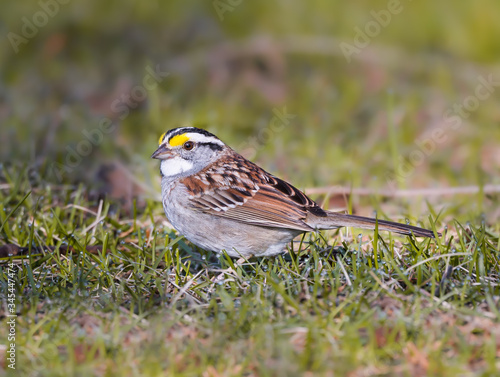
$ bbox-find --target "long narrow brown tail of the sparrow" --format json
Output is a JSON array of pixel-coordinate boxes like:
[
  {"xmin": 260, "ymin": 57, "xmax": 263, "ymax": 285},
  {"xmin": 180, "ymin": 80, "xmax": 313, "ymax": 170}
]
[{"xmin": 314, "ymin": 211, "xmax": 441, "ymax": 238}]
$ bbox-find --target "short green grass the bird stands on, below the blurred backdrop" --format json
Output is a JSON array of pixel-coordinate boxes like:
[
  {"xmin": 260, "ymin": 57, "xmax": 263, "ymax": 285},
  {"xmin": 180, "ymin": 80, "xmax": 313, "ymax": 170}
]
[{"xmin": 0, "ymin": 167, "xmax": 500, "ymax": 376}]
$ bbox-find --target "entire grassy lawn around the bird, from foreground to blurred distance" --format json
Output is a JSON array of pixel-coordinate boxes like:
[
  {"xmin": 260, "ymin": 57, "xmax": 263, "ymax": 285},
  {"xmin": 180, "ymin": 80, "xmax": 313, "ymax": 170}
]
[{"xmin": 0, "ymin": 0, "xmax": 500, "ymax": 377}]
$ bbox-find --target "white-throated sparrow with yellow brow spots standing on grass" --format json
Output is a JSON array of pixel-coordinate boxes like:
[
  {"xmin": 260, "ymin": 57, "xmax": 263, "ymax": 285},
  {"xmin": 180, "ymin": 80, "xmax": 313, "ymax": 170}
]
[{"xmin": 151, "ymin": 126, "xmax": 439, "ymax": 259}]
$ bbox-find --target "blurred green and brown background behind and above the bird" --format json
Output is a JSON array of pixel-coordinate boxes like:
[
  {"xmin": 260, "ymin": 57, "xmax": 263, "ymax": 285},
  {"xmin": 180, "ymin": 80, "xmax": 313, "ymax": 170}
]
[{"xmin": 0, "ymin": 0, "xmax": 500, "ymax": 216}]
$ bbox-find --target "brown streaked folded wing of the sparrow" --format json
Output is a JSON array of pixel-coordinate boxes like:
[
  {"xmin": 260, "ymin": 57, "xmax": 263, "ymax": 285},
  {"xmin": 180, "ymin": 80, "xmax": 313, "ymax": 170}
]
[{"xmin": 182, "ymin": 152, "xmax": 327, "ymax": 231}]
